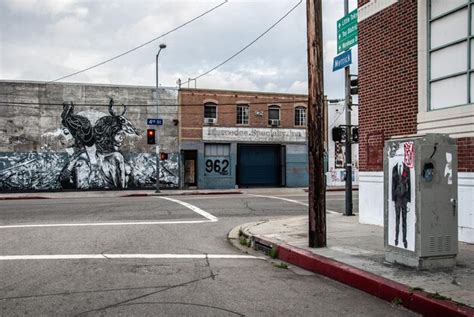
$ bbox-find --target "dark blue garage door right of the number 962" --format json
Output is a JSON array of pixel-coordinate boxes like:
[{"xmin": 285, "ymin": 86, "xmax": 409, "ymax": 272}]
[{"xmin": 237, "ymin": 145, "xmax": 281, "ymax": 186}]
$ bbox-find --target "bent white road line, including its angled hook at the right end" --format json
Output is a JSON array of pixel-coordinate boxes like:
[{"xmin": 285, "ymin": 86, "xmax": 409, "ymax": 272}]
[{"xmin": 0, "ymin": 197, "xmax": 218, "ymax": 229}]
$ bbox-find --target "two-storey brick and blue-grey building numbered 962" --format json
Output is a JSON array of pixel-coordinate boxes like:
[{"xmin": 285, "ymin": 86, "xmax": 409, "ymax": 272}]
[{"xmin": 179, "ymin": 89, "xmax": 308, "ymax": 188}]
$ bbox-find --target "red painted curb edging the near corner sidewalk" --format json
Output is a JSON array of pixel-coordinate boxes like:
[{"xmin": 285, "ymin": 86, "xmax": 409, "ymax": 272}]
[{"xmin": 252, "ymin": 236, "xmax": 474, "ymax": 317}]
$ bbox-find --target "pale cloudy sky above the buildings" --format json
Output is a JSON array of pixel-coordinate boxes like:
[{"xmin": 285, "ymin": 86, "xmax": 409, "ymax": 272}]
[{"xmin": 0, "ymin": 0, "xmax": 356, "ymax": 98}]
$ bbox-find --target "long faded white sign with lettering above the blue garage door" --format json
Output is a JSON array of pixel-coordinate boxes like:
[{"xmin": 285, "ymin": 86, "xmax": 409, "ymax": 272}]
[{"xmin": 202, "ymin": 127, "xmax": 306, "ymax": 143}]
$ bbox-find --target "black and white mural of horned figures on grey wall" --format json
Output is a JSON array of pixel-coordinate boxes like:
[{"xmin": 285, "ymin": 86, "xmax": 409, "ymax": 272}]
[{"xmin": 0, "ymin": 99, "xmax": 178, "ymax": 191}]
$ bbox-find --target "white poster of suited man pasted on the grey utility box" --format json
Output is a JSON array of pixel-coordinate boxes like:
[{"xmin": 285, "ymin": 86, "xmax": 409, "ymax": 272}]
[{"xmin": 388, "ymin": 142, "xmax": 416, "ymax": 251}]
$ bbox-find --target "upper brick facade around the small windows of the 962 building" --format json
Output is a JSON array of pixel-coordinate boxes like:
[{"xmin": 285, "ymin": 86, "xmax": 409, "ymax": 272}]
[{"xmin": 179, "ymin": 89, "xmax": 307, "ymax": 140}]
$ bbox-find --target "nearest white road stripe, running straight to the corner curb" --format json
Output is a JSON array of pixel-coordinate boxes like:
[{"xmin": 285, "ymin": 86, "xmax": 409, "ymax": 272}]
[{"xmin": 0, "ymin": 253, "xmax": 265, "ymax": 261}]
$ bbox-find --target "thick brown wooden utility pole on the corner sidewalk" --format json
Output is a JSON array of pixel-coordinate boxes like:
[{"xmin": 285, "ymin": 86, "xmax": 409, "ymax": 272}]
[{"xmin": 306, "ymin": 0, "xmax": 326, "ymax": 248}]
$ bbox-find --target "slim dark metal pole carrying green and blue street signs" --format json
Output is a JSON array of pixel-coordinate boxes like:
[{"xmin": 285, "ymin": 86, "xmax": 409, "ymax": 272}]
[{"xmin": 344, "ymin": 0, "xmax": 352, "ymax": 216}]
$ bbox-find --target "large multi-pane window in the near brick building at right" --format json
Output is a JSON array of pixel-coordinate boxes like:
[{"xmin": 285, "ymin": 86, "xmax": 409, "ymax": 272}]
[{"xmin": 428, "ymin": 0, "xmax": 474, "ymax": 110}]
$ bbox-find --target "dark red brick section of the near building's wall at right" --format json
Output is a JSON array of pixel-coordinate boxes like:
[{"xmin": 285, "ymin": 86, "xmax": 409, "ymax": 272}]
[{"xmin": 358, "ymin": 0, "xmax": 418, "ymax": 171}]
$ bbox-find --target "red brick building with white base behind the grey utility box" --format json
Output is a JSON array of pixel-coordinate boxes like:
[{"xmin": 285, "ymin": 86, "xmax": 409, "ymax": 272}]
[{"xmin": 358, "ymin": 0, "xmax": 474, "ymax": 243}]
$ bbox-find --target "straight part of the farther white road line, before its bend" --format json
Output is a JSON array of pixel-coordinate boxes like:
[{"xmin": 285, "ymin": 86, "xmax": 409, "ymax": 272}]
[{"xmin": 0, "ymin": 220, "xmax": 213, "ymax": 229}]
